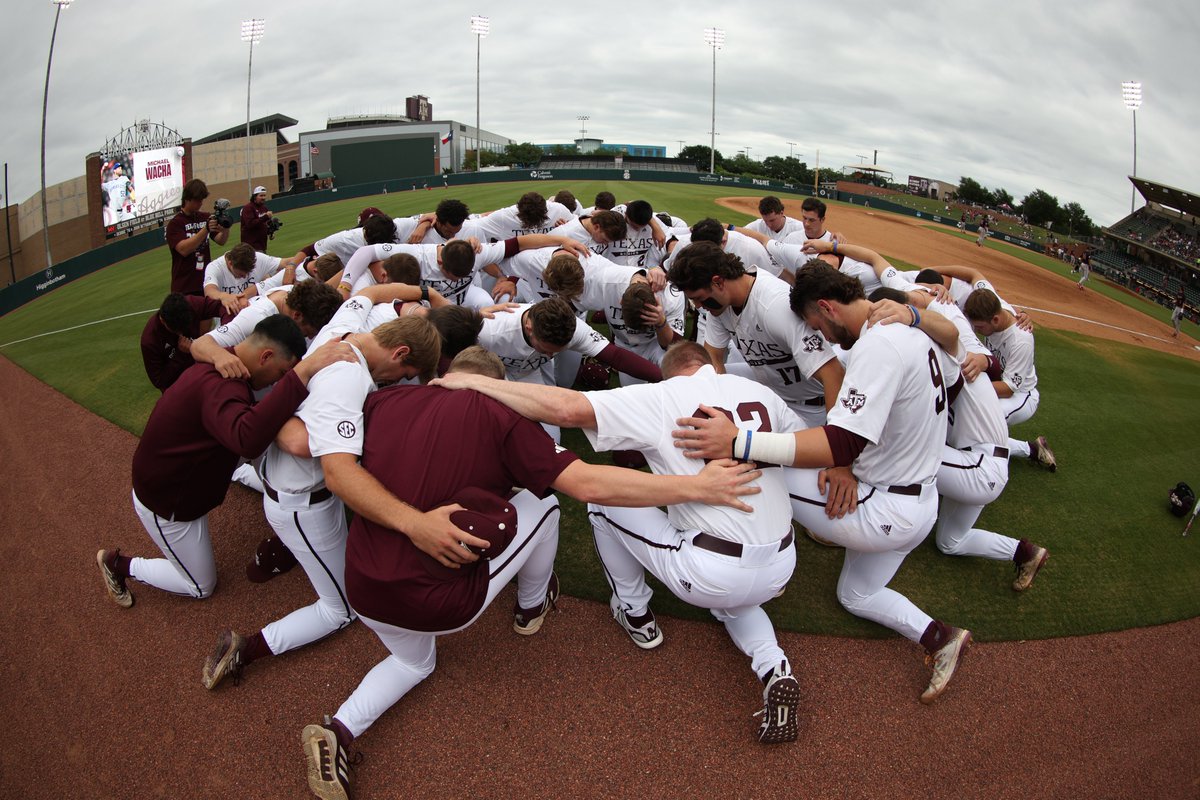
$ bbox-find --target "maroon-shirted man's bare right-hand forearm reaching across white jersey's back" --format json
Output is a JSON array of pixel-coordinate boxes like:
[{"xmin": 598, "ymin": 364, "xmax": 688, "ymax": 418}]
[{"xmin": 553, "ymin": 458, "xmax": 762, "ymax": 511}]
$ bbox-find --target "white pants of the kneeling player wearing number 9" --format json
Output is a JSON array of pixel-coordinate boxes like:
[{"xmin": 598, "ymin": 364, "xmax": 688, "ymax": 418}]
[{"xmin": 786, "ymin": 469, "xmax": 937, "ymax": 642}]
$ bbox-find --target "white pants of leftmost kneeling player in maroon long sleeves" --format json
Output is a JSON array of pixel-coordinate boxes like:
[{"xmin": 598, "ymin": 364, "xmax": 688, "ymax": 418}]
[{"xmin": 130, "ymin": 492, "xmax": 217, "ymax": 600}]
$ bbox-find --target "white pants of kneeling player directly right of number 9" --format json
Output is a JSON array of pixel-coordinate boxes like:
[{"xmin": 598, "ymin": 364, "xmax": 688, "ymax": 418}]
[{"xmin": 937, "ymin": 445, "xmax": 1018, "ymax": 560}]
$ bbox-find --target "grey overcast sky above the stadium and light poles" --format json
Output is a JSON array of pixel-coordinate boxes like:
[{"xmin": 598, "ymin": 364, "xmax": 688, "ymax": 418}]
[{"xmin": 0, "ymin": 0, "xmax": 1200, "ymax": 224}]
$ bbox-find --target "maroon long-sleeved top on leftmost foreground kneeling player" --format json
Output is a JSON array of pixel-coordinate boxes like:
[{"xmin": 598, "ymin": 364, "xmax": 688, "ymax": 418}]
[{"xmin": 133, "ymin": 363, "xmax": 308, "ymax": 522}]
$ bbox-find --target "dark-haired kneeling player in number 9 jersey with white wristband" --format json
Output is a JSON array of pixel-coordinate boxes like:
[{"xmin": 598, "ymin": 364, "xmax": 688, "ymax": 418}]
[{"xmin": 674, "ymin": 265, "xmax": 971, "ymax": 703}]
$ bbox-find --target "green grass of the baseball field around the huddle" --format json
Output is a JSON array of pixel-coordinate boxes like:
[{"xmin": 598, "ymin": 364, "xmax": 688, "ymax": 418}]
[{"xmin": 0, "ymin": 181, "xmax": 1200, "ymax": 640}]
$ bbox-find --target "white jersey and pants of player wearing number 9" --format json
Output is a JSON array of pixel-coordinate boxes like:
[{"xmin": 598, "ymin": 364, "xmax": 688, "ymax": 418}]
[{"xmin": 787, "ymin": 324, "xmax": 960, "ymax": 642}]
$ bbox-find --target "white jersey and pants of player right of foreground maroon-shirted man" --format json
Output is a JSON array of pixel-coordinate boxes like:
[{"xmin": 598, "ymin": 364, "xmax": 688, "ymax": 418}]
[{"xmin": 584, "ymin": 366, "xmax": 804, "ymax": 675}]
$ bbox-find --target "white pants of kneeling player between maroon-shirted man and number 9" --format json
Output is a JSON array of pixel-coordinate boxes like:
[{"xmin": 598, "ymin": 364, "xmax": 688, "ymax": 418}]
[{"xmin": 588, "ymin": 504, "xmax": 796, "ymax": 675}]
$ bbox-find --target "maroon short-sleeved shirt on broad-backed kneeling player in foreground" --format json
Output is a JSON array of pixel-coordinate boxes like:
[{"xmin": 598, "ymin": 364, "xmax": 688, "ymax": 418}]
[{"xmin": 346, "ymin": 386, "xmax": 578, "ymax": 631}]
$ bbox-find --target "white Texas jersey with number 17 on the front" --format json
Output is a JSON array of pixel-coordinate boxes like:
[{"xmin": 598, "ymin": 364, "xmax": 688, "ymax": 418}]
[{"xmin": 704, "ymin": 270, "xmax": 834, "ymax": 427}]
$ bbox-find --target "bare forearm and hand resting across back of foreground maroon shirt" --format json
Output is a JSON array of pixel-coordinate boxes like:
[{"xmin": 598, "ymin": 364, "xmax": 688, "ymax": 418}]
[{"xmin": 320, "ymin": 453, "xmax": 488, "ymax": 567}]
